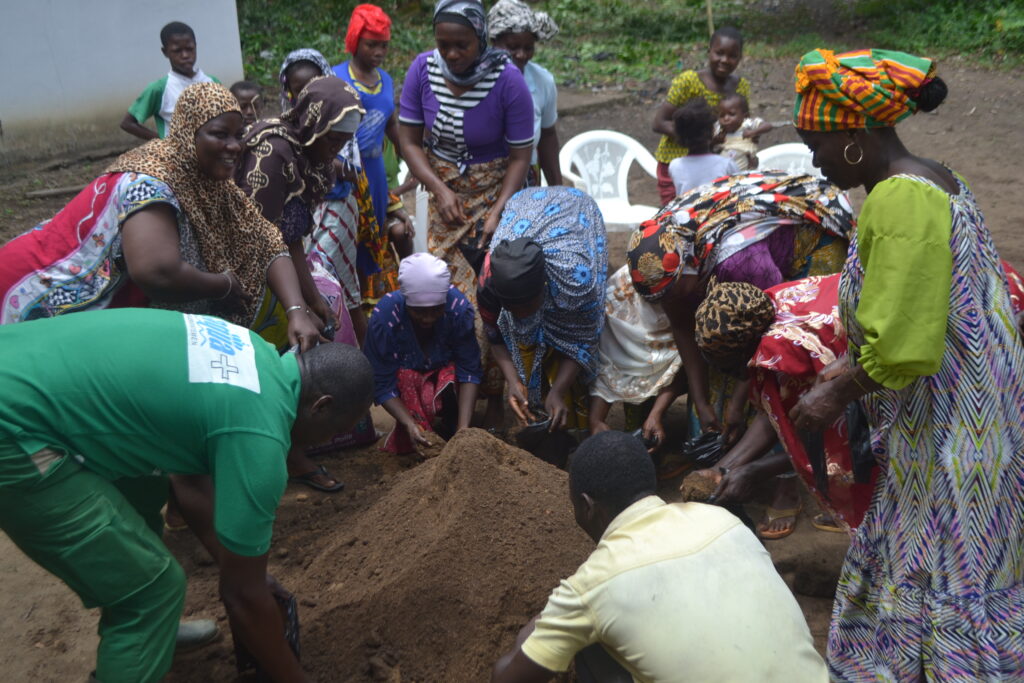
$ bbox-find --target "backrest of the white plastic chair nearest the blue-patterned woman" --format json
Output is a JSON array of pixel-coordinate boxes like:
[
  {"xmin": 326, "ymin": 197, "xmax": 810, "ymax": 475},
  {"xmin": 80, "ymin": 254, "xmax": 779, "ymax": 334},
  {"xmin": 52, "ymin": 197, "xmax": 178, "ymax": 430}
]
[{"xmin": 558, "ymin": 130, "xmax": 657, "ymax": 201}]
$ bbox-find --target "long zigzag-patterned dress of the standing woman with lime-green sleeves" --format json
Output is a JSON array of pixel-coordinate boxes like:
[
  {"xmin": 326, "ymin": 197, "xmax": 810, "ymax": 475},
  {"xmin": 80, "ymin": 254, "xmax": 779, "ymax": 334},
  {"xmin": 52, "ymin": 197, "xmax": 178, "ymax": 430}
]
[{"xmin": 828, "ymin": 176, "xmax": 1024, "ymax": 681}]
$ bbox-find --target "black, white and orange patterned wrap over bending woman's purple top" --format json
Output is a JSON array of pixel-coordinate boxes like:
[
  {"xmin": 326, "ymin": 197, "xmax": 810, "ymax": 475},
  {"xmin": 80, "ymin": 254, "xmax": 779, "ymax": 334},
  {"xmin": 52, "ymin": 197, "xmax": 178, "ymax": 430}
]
[{"xmin": 628, "ymin": 171, "xmax": 854, "ymax": 444}]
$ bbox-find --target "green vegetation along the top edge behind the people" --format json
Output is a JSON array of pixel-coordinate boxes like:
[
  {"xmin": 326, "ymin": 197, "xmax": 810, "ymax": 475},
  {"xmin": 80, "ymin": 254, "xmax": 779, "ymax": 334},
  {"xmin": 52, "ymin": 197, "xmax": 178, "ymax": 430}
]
[{"xmin": 238, "ymin": 0, "xmax": 1024, "ymax": 93}]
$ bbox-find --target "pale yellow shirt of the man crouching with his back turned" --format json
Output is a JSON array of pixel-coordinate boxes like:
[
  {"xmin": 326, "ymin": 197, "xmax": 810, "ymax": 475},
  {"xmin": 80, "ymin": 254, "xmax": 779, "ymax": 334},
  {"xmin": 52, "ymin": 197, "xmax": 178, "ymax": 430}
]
[{"xmin": 522, "ymin": 496, "xmax": 827, "ymax": 683}]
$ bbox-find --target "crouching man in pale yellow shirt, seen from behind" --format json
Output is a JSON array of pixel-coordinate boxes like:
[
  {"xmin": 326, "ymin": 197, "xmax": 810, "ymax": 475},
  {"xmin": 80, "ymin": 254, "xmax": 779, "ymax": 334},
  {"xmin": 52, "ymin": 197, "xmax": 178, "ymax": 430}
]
[{"xmin": 492, "ymin": 431, "xmax": 827, "ymax": 683}]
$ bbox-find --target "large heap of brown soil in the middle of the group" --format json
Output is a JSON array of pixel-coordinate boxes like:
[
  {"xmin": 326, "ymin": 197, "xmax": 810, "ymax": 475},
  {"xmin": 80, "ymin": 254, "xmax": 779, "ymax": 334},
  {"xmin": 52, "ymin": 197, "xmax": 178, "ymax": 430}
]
[{"xmin": 168, "ymin": 429, "xmax": 593, "ymax": 683}]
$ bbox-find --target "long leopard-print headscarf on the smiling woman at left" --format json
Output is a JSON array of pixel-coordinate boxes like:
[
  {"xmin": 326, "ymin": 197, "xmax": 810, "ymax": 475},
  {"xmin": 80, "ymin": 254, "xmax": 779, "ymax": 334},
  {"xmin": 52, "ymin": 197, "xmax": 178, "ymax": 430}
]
[{"xmin": 106, "ymin": 83, "xmax": 288, "ymax": 327}]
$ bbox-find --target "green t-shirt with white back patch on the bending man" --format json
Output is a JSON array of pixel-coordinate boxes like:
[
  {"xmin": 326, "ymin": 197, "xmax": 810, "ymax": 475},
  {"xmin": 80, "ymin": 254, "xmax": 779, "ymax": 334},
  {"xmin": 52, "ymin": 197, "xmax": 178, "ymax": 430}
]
[{"xmin": 0, "ymin": 308, "xmax": 300, "ymax": 556}]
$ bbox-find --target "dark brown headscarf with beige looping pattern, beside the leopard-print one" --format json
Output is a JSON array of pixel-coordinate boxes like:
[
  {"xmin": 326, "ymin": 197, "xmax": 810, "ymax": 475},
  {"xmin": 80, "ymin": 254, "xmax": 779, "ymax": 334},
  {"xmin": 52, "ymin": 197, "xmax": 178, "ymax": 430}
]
[{"xmin": 237, "ymin": 76, "xmax": 366, "ymax": 221}]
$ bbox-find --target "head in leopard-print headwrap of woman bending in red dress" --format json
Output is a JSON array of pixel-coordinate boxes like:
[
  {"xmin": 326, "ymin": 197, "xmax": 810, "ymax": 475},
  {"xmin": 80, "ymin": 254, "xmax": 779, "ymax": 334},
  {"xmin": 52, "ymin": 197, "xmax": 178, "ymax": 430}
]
[{"xmin": 694, "ymin": 279, "xmax": 775, "ymax": 374}]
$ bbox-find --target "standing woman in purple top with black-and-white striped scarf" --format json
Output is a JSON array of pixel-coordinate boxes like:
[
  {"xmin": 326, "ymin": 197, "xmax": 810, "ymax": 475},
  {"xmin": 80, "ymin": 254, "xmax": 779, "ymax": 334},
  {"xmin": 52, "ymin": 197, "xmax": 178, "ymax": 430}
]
[{"xmin": 398, "ymin": 0, "xmax": 534, "ymax": 423}]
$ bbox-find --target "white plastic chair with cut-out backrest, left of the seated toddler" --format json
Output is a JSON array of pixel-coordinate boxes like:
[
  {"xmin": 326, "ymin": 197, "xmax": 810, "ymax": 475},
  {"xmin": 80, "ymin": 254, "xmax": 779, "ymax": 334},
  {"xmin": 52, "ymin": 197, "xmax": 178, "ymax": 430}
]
[{"xmin": 558, "ymin": 130, "xmax": 657, "ymax": 230}]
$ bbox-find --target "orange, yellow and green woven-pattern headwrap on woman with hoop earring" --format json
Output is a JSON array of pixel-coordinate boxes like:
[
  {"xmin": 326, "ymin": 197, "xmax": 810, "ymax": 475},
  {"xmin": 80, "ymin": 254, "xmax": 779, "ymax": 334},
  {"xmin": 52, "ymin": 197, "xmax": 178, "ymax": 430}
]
[{"xmin": 793, "ymin": 49, "xmax": 935, "ymax": 131}]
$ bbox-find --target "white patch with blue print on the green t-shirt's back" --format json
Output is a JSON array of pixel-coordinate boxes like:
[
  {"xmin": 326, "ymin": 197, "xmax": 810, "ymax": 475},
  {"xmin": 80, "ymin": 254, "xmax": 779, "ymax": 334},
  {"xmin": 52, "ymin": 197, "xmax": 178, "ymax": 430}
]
[{"xmin": 184, "ymin": 315, "xmax": 259, "ymax": 393}]
